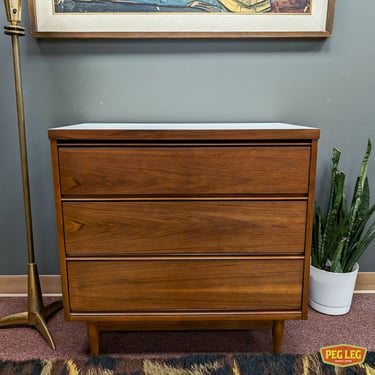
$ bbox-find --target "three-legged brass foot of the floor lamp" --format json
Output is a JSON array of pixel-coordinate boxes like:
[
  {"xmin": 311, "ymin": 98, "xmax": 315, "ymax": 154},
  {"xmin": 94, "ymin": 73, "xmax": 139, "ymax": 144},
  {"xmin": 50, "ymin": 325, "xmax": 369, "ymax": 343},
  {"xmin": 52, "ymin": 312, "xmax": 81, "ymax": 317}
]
[{"xmin": 0, "ymin": 263, "xmax": 63, "ymax": 350}]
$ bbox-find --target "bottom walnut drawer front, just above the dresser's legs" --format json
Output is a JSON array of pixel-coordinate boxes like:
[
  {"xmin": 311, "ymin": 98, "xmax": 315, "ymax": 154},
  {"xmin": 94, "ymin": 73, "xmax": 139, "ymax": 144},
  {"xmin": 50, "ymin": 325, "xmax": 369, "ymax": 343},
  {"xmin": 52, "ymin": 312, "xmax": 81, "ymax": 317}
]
[{"xmin": 67, "ymin": 258, "xmax": 303, "ymax": 314}]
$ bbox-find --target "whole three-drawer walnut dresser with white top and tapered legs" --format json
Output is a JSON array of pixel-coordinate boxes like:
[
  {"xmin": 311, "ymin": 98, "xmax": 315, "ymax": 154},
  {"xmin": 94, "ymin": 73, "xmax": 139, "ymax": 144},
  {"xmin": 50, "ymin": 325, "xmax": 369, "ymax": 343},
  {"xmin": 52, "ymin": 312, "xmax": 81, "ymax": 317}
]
[{"xmin": 49, "ymin": 123, "xmax": 319, "ymax": 354}]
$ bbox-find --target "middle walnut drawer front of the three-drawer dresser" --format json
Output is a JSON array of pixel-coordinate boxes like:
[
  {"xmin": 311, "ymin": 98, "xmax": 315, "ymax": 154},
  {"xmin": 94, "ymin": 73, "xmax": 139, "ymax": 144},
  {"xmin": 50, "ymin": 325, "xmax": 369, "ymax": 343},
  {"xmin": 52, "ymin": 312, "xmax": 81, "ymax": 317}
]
[{"xmin": 63, "ymin": 201, "xmax": 307, "ymax": 256}]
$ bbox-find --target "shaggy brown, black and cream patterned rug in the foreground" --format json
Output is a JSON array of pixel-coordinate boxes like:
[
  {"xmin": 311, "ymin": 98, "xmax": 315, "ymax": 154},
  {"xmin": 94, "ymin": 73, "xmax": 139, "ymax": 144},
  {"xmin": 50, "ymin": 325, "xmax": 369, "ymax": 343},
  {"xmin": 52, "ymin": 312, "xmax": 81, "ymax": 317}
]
[{"xmin": 0, "ymin": 352, "xmax": 375, "ymax": 375}]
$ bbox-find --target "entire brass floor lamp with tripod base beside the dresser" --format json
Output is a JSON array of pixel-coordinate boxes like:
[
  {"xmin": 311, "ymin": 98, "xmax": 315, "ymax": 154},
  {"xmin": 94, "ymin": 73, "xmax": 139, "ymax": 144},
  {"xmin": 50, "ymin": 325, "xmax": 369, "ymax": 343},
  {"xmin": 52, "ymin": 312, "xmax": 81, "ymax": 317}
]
[{"xmin": 0, "ymin": 0, "xmax": 62, "ymax": 350}]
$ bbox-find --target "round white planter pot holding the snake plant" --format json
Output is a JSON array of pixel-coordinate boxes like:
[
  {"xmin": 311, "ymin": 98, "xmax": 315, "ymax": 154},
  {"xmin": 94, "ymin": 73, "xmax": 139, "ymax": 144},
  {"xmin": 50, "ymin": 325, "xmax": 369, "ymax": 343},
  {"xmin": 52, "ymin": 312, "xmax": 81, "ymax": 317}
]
[{"xmin": 309, "ymin": 263, "xmax": 359, "ymax": 315}]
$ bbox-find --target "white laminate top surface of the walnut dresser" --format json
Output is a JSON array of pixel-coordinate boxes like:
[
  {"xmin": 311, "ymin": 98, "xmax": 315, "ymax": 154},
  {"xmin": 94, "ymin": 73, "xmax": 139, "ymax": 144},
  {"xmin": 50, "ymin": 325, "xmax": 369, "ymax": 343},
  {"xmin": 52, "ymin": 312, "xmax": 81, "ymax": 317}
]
[{"xmin": 53, "ymin": 122, "xmax": 316, "ymax": 130}]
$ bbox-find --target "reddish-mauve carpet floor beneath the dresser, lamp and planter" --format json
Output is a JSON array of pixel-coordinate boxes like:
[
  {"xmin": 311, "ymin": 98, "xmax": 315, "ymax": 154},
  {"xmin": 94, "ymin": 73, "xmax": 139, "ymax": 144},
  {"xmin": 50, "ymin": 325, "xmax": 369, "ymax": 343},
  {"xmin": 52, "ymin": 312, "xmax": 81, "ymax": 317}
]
[{"xmin": 0, "ymin": 294, "xmax": 375, "ymax": 360}]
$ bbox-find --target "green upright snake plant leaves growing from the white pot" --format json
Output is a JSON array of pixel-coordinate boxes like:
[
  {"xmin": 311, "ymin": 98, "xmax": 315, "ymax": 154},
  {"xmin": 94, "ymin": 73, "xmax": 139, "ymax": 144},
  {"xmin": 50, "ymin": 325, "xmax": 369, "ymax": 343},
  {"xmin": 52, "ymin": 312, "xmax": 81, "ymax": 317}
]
[{"xmin": 311, "ymin": 140, "xmax": 375, "ymax": 272}]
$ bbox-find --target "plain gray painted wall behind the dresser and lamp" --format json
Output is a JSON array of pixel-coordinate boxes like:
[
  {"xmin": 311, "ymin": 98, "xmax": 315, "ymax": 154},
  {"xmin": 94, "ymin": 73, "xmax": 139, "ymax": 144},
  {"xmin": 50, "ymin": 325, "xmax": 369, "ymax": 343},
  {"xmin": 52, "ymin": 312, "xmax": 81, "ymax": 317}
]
[{"xmin": 0, "ymin": 0, "xmax": 375, "ymax": 274}]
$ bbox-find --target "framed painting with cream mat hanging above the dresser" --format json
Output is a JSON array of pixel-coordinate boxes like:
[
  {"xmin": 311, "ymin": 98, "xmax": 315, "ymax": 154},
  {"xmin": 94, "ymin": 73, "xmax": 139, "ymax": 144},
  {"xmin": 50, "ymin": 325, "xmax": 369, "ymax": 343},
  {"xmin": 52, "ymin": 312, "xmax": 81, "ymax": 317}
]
[{"xmin": 28, "ymin": 0, "xmax": 334, "ymax": 38}]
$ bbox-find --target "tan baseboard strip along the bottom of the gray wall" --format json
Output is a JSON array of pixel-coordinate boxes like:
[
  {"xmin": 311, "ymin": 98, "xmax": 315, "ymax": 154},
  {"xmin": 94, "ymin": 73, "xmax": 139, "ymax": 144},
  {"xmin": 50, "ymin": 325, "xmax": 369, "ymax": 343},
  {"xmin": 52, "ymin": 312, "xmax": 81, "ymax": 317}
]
[{"xmin": 0, "ymin": 272, "xmax": 375, "ymax": 297}]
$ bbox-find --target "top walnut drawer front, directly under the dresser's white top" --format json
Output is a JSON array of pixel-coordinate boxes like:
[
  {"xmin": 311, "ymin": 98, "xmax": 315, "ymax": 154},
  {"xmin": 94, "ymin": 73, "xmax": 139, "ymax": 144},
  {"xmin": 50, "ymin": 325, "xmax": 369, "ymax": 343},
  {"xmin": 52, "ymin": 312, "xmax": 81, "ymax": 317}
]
[{"xmin": 59, "ymin": 146, "xmax": 310, "ymax": 196}]
